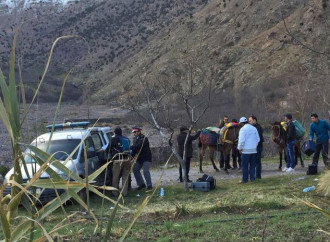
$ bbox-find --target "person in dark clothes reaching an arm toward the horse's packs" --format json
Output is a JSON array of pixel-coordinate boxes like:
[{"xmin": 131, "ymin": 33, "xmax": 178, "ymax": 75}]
[{"xmin": 177, "ymin": 126, "xmax": 201, "ymax": 182}]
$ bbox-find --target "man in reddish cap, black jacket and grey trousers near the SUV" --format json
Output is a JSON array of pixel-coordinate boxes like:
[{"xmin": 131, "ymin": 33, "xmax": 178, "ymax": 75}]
[{"xmin": 131, "ymin": 127, "xmax": 152, "ymax": 190}]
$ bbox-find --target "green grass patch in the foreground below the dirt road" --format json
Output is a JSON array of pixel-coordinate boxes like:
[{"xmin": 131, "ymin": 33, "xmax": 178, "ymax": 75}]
[{"xmin": 3, "ymin": 172, "xmax": 330, "ymax": 241}]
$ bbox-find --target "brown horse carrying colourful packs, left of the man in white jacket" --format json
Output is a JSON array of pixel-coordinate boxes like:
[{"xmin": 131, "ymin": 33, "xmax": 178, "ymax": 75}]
[{"xmin": 199, "ymin": 125, "xmax": 240, "ymax": 174}]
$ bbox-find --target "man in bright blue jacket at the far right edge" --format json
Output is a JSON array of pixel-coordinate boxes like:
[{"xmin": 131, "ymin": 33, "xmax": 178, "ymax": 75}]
[{"xmin": 309, "ymin": 113, "xmax": 330, "ymax": 168}]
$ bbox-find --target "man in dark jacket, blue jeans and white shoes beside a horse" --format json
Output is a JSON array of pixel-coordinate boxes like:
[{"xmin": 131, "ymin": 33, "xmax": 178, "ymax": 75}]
[{"xmin": 283, "ymin": 113, "xmax": 296, "ymax": 172}]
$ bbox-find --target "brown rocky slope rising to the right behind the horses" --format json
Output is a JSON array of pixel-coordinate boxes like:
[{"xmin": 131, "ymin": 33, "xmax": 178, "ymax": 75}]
[{"xmin": 95, "ymin": 0, "xmax": 330, "ymax": 118}]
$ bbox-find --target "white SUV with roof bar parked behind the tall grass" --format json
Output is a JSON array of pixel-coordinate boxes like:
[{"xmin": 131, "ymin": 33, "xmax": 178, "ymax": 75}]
[{"xmin": 4, "ymin": 122, "xmax": 113, "ymax": 202}]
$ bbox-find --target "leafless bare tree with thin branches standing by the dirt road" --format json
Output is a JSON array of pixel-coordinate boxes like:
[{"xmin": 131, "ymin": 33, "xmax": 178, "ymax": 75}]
[{"xmin": 126, "ymin": 47, "xmax": 212, "ymax": 191}]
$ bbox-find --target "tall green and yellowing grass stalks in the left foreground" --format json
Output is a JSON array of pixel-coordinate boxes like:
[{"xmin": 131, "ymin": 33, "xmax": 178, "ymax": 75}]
[{"xmin": 0, "ymin": 31, "xmax": 112, "ymax": 241}]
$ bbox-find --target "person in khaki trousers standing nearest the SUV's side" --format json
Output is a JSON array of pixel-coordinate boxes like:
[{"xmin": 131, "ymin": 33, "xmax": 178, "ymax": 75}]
[{"xmin": 109, "ymin": 127, "xmax": 131, "ymax": 197}]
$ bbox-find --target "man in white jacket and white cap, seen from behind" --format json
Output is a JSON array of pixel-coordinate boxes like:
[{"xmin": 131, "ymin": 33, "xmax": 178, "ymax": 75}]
[{"xmin": 237, "ymin": 117, "xmax": 260, "ymax": 183}]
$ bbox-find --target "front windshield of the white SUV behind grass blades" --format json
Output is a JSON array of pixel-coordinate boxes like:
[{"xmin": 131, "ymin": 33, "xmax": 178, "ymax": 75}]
[{"xmin": 24, "ymin": 139, "xmax": 81, "ymax": 163}]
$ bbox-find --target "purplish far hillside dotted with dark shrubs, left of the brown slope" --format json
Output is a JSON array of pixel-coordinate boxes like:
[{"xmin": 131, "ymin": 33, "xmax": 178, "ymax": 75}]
[{"xmin": 0, "ymin": 0, "xmax": 207, "ymax": 101}]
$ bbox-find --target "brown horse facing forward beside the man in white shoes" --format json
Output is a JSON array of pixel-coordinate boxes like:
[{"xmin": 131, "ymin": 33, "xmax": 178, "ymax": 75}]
[{"xmin": 272, "ymin": 121, "xmax": 304, "ymax": 170}]
